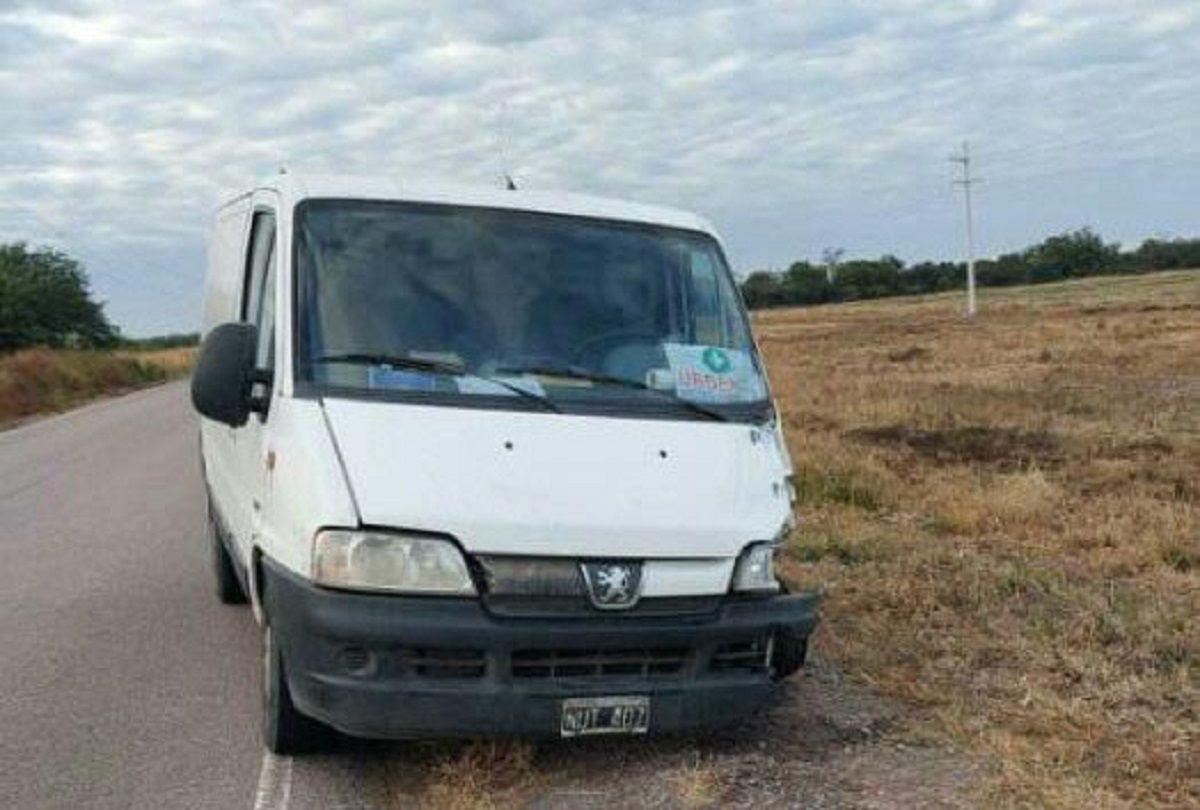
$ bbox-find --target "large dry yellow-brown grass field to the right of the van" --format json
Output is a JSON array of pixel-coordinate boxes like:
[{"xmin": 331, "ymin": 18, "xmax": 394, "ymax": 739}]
[{"xmin": 755, "ymin": 271, "xmax": 1200, "ymax": 808}]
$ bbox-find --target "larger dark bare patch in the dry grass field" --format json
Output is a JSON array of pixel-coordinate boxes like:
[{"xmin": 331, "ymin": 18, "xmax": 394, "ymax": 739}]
[{"xmin": 846, "ymin": 425, "xmax": 1064, "ymax": 472}]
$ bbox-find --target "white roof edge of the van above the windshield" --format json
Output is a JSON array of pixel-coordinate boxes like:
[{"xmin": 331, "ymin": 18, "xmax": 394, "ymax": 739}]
[{"xmin": 222, "ymin": 170, "xmax": 716, "ymax": 236}]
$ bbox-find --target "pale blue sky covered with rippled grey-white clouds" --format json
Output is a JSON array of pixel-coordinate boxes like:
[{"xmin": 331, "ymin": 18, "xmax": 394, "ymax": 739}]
[{"xmin": 0, "ymin": 0, "xmax": 1200, "ymax": 335}]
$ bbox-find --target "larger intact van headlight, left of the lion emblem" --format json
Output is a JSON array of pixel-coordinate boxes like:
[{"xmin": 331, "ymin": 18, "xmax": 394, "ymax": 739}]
[{"xmin": 312, "ymin": 529, "xmax": 475, "ymax": 596}]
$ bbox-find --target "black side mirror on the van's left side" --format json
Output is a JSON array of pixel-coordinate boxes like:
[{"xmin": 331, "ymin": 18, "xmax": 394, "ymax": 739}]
[{"xmin": 192, "ymin": 323, "xmax": 270, "ymax": 427}]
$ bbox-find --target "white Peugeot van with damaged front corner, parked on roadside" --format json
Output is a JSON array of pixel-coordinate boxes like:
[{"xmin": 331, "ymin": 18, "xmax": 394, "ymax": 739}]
[{"xmin": 192, "ymin": 174, "xmax": 816, "ymax": 752}]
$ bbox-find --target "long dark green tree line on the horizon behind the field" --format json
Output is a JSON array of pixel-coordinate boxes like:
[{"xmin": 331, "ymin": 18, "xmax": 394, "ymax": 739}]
[{"xmin": 742, "ymin": 228, "xmax": 1200, "ymax": 308}]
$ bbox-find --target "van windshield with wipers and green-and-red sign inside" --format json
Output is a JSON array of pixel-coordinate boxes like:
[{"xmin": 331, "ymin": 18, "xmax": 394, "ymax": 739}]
[{"xmin": 295, "ymin": 200, "xmax": 767, "ymax": 420}]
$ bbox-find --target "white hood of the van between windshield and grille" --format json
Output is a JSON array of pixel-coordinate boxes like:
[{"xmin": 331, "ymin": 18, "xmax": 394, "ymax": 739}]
[{"xmin": 323, "ymin": 398, "xmax": 791, "ymax": 558}]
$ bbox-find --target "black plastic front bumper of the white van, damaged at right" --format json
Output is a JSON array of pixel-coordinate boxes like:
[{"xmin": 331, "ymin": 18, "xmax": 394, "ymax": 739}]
[{"xmin": 263, "ymin": 559, "xmax": 817, "ymax": 738}]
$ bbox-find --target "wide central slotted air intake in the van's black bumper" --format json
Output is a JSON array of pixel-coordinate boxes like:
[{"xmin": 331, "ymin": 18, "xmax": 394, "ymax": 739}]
[{"xmin": 511, "ymin": 647, "xmax": 692, "ymax": 678}]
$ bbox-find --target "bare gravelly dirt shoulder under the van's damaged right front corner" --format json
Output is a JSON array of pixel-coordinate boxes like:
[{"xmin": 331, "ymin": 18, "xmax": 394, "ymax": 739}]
[{"xmin": 527, "ymin": 661, "xmax": 979, "ymax": 809}]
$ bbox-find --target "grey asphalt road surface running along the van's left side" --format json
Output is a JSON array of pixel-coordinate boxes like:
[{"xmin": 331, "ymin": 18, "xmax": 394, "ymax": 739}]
[{"xmin": 0, "ymin": 384, "xmax": 263, "ymax": 808}]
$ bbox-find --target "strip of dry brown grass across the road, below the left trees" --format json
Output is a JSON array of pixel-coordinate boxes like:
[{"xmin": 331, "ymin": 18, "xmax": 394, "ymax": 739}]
[{"xmin": 0, "ymin": 348, "xmax": 196, "ymax": 427}]
